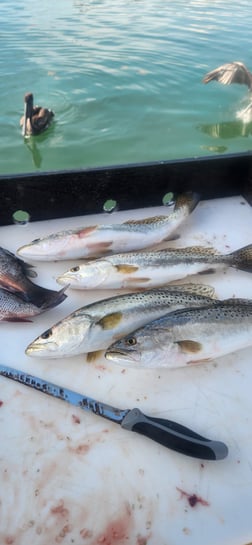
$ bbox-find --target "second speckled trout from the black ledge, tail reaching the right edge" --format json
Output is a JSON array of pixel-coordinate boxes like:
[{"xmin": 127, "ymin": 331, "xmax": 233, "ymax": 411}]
[{"xmin": 57, "ymin": 244, "xmax": 252, "ymax": 289}]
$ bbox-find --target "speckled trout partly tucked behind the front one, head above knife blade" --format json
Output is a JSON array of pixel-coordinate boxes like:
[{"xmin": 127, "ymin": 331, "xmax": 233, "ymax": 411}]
[{"xmin": 26, "ymin": 284, "xmax": 214, "ymax": 361}]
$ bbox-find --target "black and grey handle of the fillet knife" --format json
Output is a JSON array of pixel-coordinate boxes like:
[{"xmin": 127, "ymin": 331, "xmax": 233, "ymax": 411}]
[{"xmin": 121, "ymin": 409, "xmax": 228, "ymax": 460}]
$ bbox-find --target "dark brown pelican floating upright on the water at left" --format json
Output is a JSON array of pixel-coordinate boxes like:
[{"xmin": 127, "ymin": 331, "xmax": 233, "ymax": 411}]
[{"xmin": 20, "ymin": 93, "xmax": 54, "ymax": 136}]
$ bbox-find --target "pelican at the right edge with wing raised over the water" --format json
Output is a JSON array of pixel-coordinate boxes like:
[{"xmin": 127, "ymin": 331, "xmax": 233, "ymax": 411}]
[{"xmin": 202, "ymin": 61, "xmax": 252, "ymax": 123}]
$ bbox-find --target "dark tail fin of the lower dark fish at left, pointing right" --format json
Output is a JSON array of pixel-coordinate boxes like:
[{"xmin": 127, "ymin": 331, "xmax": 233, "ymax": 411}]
[{"xmin": 26, "ymin": 284, "xmax": 69, "ymax": 310}]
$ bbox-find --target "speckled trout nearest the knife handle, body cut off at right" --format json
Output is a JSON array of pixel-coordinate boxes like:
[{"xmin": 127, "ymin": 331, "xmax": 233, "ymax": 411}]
[{"xmin": 105, "ymin": 299, "xmax": 252, "ymax": 369}]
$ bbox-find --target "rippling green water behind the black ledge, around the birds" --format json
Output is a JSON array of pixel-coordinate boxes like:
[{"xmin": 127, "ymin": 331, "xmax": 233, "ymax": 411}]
[{"xmin": 0, "ymin": 0, "xmax": 252, "ymax": 174}]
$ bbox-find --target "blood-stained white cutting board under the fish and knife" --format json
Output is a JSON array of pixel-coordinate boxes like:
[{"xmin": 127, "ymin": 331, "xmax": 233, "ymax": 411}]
[{"xmin": 0, "ymin": 197, "xmax": 252, "ymax": 545}]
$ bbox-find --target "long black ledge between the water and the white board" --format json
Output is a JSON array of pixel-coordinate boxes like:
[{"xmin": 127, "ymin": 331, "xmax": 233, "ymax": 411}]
[{"xmin": 0, "ymin": 153, "xmax": 252, "ymax": 225}]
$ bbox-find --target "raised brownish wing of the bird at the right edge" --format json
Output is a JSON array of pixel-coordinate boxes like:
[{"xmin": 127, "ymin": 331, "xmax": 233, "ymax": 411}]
[{"xmin": 202, "ymin": 61, "xmax": 252, "ymax": 88}]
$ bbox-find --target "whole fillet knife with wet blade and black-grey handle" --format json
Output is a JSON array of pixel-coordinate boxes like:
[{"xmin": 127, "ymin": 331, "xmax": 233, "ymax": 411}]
[{"xmin": 0, "ymin": 364, "xmax": 228, "ymax": 460}]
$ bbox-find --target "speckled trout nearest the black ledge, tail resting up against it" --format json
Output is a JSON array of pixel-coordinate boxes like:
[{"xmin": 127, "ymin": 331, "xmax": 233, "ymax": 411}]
[{"xmin": 17, "ymin": 192, "xmax": 199, "ymax": 261}]
